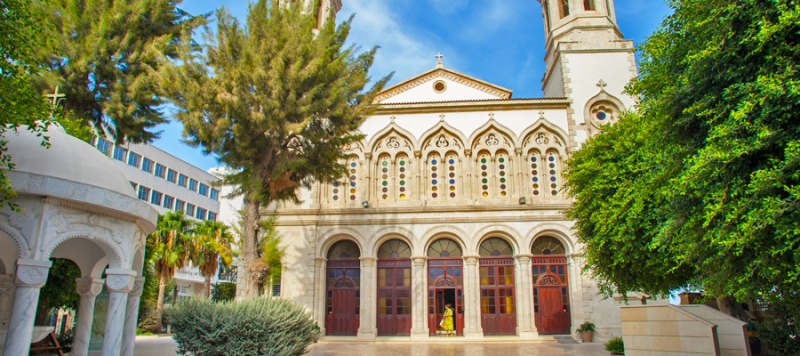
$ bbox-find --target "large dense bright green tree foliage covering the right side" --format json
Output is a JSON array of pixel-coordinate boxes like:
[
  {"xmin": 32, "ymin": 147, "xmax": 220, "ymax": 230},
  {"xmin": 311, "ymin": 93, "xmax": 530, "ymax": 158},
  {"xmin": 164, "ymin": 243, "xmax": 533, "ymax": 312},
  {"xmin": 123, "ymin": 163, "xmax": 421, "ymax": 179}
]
[{"xmin": 566, "ymin": 0, "xmax": 800, "ymax": 300}]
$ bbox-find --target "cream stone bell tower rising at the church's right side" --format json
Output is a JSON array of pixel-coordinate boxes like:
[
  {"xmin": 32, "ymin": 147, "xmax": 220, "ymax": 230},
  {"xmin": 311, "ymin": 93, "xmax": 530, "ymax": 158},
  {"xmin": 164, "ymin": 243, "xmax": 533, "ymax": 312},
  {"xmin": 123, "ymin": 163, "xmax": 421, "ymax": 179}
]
[{"xmin": 538, "ymin": 0, "xmax": 637, "ymax": 149}]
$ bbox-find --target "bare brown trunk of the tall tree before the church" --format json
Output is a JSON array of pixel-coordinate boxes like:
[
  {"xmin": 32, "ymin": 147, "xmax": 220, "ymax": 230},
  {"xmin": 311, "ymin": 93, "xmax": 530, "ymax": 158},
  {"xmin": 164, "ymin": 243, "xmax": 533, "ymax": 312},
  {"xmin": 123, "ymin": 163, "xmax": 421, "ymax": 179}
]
[{"xmin": 242, "ymin": 198, "xmax": 263, "ymax": 300}]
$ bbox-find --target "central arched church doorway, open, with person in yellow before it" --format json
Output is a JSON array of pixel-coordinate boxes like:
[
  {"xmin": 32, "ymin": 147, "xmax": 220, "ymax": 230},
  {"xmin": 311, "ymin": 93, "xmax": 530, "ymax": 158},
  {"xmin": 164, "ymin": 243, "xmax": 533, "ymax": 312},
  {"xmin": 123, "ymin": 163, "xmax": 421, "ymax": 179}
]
[{"xmin": 428, "ymin": 239, "xmax": 464, "ymax": 335}]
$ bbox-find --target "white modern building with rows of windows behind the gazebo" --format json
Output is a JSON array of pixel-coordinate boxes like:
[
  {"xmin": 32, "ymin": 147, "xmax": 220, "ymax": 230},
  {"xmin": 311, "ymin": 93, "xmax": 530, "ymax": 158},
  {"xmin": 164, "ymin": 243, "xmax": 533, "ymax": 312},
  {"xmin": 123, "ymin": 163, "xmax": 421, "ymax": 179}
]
[{"xmin": 92, "ymin": 138, "xmax": 220, "ymax": 300}]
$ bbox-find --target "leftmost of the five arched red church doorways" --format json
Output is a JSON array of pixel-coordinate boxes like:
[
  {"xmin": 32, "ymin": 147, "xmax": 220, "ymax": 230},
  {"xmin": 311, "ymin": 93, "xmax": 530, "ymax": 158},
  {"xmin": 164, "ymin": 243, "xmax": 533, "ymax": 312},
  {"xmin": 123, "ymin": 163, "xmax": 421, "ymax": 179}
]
[{"xmin": 325, "ymin": 240, "xmax": 361, "ymax": 335}]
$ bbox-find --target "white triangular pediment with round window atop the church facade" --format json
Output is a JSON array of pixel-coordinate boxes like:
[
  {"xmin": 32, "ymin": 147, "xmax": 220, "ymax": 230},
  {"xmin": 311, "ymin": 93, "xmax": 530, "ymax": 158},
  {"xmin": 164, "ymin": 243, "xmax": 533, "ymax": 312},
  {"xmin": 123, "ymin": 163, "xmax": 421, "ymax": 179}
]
[{"xmin": 375, "ymin": 68, "xmax": 511, "ymax": 104}]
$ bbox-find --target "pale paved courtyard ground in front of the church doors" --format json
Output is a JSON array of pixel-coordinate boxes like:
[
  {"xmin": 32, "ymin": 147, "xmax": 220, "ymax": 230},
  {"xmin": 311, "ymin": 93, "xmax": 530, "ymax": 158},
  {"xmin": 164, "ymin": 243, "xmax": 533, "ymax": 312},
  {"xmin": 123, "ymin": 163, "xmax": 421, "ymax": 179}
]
[{"xmin": 135, "ymin": 337, "xmax": 608, "ymax": 356}]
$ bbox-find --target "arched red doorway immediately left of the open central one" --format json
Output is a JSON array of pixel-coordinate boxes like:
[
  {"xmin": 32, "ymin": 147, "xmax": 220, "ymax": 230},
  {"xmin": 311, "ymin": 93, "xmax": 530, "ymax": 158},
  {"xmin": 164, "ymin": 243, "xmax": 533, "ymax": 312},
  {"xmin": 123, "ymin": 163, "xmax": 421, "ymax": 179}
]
[{"xmin": 378, "ymin": 239, "xmax": 411, "ymax": 336}]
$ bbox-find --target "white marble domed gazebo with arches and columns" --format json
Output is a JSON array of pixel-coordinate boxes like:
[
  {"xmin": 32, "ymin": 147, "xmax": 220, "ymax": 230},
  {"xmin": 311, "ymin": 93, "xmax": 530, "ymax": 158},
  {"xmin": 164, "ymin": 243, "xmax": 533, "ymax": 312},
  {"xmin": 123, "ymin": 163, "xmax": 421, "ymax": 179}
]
[{"xmin": 0, "ymin": 126, "xmax": 158, "ymax": 356}]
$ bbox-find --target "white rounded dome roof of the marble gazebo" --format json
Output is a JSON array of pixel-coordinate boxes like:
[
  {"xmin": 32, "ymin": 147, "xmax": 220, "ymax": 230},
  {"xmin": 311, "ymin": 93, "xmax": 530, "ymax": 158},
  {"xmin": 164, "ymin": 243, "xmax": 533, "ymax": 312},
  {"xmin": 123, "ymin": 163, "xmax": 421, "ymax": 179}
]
[{"xmin": 4, "ymin": 125, "xmax": 136, "ymax": 197}]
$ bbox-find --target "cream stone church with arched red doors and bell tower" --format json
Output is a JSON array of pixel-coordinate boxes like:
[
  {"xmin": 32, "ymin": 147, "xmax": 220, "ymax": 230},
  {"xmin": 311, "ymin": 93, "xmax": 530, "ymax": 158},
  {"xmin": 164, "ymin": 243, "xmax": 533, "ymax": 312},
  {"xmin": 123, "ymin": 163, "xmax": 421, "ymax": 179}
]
[{"xmin": 264, "ymin": 0, "xmax": 663, "ymax": 340}]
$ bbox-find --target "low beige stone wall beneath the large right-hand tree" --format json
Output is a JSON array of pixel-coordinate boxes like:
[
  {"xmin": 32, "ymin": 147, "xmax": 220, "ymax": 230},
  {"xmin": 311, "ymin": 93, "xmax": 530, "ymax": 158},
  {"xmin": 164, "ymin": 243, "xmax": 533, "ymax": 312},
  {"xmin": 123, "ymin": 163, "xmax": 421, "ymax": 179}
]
[{"xmin": 620, "ymin": 305, "xmax": 751, "ymax": 356}]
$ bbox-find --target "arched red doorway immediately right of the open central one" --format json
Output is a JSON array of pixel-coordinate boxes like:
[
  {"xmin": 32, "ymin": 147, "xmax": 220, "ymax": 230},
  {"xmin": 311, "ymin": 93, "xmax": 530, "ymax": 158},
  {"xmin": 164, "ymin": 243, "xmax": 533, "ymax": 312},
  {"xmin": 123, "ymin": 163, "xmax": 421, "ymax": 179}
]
[{"xmin": 479, "ymin": 237, "xmax": 517, "ymax": 335}]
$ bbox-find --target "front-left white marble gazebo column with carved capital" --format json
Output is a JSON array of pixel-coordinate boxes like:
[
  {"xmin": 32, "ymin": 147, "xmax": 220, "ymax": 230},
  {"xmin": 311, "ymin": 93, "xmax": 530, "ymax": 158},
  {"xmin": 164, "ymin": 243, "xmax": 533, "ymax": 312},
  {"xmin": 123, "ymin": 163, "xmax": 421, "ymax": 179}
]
[{"xmin": 3, "ymin": 259, "xmax": 53, "ymax": 356}]
